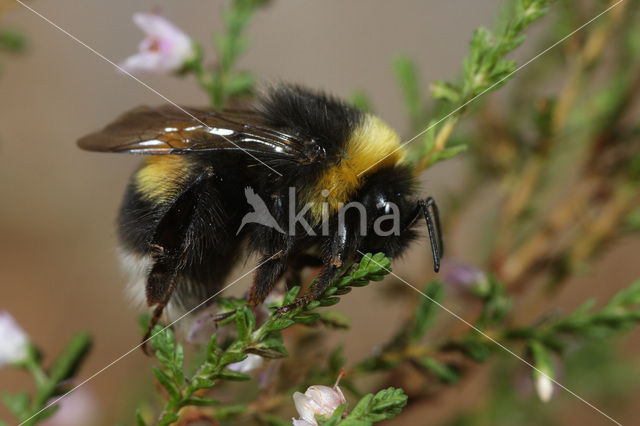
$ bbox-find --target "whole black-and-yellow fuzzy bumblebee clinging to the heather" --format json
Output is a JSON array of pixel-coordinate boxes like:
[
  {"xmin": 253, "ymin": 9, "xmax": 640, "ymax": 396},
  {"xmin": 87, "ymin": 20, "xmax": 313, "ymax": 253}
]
[{"xmin": 78, "ymin": 86, "xmax": 443, "ymax": 342}]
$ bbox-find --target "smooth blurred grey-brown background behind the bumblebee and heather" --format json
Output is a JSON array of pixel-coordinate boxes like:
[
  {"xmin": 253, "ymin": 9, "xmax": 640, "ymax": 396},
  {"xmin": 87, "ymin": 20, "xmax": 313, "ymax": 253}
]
[{"xmin": 0, "ymin": 0, "xmax": 640, "ymax": 425}]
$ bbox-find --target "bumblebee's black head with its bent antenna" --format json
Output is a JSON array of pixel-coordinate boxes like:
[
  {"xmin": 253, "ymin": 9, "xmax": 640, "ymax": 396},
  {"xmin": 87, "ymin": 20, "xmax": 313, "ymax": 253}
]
[{"xmin": 358, "ymin": 165, "xmax": 443, "ymax": 272}]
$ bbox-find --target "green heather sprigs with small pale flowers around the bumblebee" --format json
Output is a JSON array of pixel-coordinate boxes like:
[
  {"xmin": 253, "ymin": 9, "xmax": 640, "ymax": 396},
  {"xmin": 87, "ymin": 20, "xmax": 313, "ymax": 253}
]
[{"xmin": 3, "ymin": 0, "xmax": 640, "ymax": 426}]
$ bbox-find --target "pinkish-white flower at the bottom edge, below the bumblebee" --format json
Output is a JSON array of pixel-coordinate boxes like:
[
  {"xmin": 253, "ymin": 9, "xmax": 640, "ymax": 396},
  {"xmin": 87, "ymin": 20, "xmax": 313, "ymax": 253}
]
[{"xmin": 292, "ymin": 379, "xmax": 347, "ymax": 426}]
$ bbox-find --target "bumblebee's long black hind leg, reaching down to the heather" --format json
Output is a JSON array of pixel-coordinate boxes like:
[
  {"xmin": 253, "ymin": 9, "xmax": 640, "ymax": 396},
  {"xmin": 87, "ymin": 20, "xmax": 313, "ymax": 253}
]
[{"xmin": 142, "ymin": 168, "xmax": 213, "ymax": 353}]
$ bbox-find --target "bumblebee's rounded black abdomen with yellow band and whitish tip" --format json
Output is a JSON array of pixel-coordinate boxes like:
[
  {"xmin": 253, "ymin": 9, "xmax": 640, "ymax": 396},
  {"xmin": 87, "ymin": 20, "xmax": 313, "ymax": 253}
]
[{"xmin": 118, "ymin": 156, "xmax": 247, "ymax": 314}]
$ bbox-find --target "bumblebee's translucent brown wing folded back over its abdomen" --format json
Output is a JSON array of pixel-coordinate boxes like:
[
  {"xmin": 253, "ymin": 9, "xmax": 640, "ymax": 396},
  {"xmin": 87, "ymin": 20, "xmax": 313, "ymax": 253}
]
[{"xmin": 78, "ymin": 105, "xmax": 323, "ymax": 164}]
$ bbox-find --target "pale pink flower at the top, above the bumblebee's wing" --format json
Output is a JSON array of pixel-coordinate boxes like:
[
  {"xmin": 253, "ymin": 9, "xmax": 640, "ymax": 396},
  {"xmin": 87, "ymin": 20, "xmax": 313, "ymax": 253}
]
[{"xmin": 120, "ymin": 13, "xmax": 196, "ymax": 74}]
